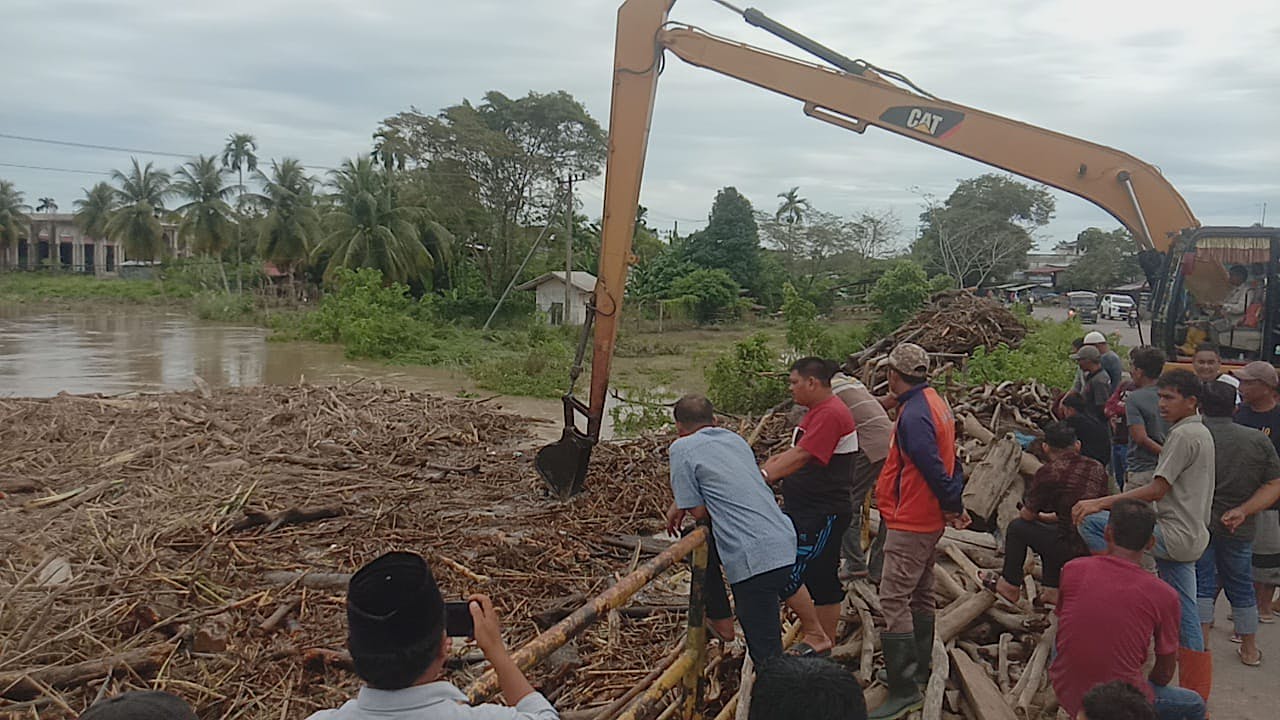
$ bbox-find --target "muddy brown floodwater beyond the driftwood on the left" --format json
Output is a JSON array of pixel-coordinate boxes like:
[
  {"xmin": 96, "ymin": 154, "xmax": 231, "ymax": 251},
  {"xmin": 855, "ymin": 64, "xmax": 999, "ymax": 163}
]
[{"xmin": 0, "ymin": 304, "xmax": 567, "ymax": 437}]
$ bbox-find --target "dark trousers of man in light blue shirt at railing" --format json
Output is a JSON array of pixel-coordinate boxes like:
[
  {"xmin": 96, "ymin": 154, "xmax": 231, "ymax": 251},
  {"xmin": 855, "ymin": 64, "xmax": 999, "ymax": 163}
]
[{"xmin": 705, "ymin": 532, "xmax": 791, "ymax": 667}]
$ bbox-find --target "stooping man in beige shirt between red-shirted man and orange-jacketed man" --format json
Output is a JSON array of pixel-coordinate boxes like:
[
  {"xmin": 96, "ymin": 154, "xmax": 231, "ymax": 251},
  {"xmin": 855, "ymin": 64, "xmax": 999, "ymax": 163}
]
[{"xmin": 831, "ymin": 373, "xmax": 893, "ymax": 580}]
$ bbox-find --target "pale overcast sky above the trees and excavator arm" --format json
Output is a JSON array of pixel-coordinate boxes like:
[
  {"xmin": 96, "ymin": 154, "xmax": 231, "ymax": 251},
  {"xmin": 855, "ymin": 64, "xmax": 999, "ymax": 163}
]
[{"xmin": 0, "ymin": 0, "xmax": 1280, "ymax": 245}]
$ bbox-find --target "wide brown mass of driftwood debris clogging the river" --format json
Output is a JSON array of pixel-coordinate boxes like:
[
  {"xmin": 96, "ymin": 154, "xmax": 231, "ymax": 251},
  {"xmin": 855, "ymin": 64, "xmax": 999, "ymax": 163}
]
[{"xmin": 0, "ymin": 384, "xmax": 737, "ymax": 719}]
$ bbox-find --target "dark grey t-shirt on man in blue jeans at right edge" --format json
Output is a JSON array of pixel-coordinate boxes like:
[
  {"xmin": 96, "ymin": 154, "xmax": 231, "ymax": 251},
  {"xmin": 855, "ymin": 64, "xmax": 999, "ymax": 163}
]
[{"xmin": 1204, "ymin": 418, "xmax": 1280, "ymax": 542}]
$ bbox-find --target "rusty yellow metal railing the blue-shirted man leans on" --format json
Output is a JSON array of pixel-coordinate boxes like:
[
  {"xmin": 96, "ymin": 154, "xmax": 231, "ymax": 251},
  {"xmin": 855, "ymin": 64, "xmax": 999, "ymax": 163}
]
[{"xmin": 467, "ymin": 524, "xmax": 710, "ymax": 720}]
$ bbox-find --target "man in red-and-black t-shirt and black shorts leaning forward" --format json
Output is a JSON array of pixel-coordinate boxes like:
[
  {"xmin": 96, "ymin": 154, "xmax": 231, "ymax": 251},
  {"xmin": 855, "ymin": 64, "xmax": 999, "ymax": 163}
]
[{"xmin": 760, "ymin": 357, "xmax": 858, "ymax": 652}]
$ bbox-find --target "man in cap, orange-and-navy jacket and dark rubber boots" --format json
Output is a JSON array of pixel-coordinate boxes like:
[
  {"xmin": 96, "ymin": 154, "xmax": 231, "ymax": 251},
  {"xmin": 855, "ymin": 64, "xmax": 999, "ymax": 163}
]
[{"xmin": 870, "ymin": 342, "xmax": 969, "ymax": 720}]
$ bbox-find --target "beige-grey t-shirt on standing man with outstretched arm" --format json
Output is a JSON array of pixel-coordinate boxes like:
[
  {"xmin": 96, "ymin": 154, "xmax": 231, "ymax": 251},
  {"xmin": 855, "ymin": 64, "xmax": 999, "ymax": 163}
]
[{"xmin": 1156, "ymin": 415, "xmax": 1216, "ymax": 562}]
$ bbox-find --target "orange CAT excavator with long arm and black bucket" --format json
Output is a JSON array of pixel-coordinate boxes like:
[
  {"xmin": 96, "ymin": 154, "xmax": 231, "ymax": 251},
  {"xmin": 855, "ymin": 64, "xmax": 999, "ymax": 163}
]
[{"xmin": 535, "ymin": 0, "xmax": 1280, "ymax": 497}]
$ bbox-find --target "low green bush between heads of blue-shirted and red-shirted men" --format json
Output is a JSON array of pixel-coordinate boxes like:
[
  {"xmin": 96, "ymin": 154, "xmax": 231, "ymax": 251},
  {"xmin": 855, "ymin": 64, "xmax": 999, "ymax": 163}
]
[{"xmin": 707, "ymin": 333, "xmax": 787, "ymax": 414}]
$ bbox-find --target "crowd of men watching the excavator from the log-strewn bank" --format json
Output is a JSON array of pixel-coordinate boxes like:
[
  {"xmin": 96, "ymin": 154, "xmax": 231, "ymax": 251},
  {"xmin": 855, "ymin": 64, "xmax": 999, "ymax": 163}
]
[{"xmin": 83, "ymin": 333, "xmax": 1280, "ymax": 720}]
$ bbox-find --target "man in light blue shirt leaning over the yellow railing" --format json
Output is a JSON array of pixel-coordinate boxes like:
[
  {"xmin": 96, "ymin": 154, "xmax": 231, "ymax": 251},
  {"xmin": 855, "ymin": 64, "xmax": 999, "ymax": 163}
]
[{"xmin": 667, "ymin": 395, "xmax": 832, "ymax": 664}]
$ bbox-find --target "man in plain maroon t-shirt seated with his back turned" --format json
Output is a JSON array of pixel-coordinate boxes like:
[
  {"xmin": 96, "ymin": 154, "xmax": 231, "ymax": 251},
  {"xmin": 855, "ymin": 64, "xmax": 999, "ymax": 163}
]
[{"xmin": 1050, "ymin": 500, "xmax": 1204, "ymax": 720}]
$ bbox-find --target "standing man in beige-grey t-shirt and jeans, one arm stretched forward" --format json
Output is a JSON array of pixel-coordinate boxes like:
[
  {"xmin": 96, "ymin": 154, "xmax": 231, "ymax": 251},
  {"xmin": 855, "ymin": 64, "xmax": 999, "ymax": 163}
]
[{"xmin": 1071, "ymin": 370, "xmax": 1216, "ymax": 701}]
